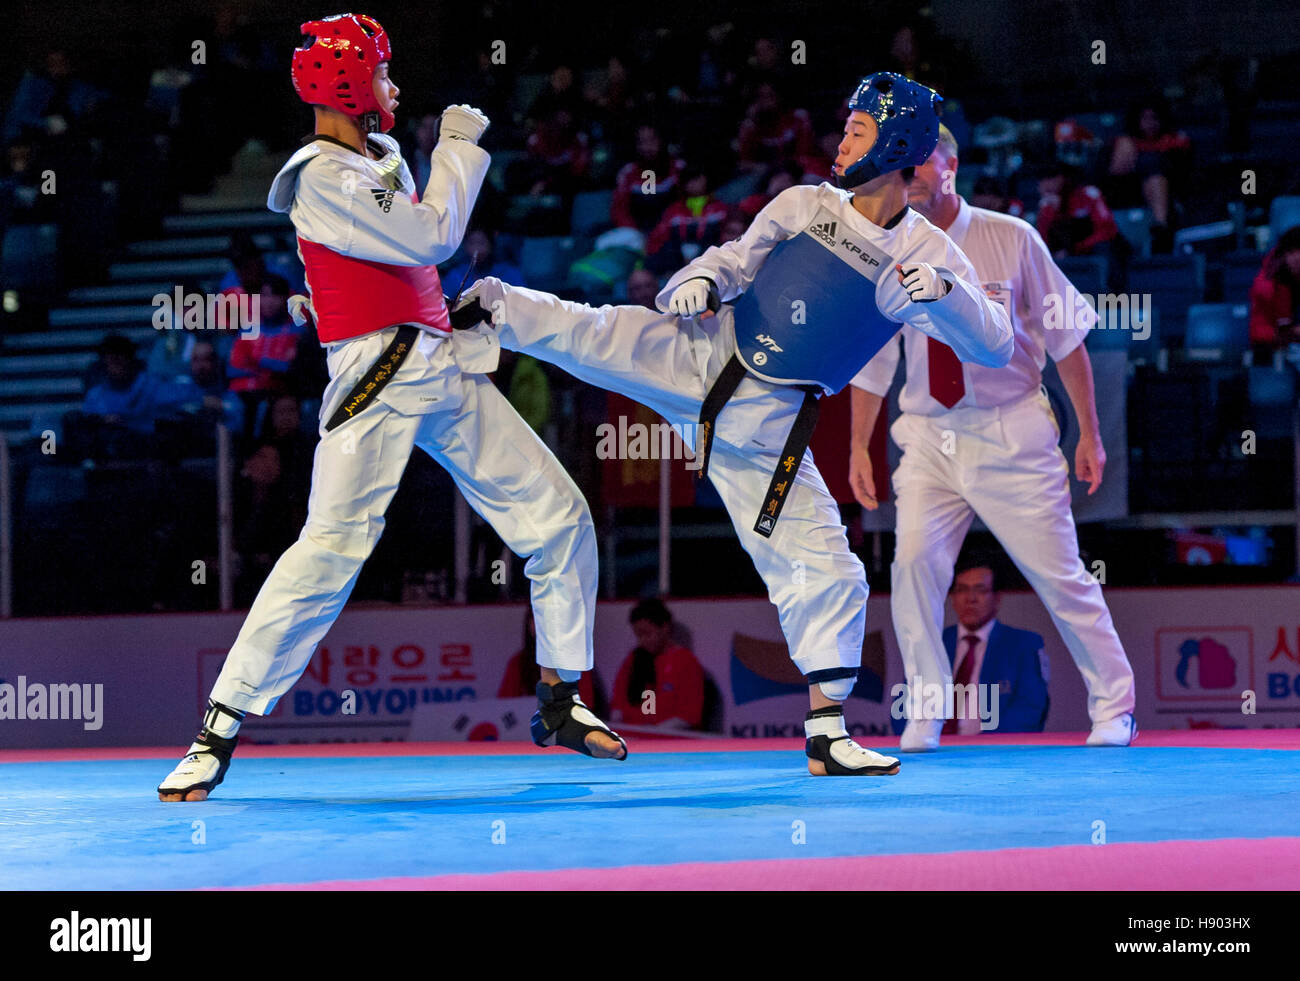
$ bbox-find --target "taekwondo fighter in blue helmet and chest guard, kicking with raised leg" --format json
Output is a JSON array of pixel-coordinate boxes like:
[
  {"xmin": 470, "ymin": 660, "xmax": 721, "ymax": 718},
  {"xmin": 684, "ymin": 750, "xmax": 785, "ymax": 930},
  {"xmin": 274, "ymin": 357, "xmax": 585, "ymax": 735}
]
[{"xmin": 451, "ymin": 73, "xmax": 1013, "ymax": 776}]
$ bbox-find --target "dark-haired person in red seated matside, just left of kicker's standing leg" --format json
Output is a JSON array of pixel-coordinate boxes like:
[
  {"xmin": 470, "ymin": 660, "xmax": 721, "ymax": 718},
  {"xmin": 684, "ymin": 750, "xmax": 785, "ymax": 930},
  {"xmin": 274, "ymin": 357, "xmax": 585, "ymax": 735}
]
[{"xmin": 610, "ymin": 599, "xmax": 705, "ymax": 729}]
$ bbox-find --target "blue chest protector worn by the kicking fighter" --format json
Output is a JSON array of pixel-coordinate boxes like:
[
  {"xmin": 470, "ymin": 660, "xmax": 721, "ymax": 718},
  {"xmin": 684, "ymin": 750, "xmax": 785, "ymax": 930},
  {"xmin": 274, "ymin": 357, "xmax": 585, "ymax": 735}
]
[{"xmin": 733, "ymin": 218, "xmax": 900, "ymax": 395}]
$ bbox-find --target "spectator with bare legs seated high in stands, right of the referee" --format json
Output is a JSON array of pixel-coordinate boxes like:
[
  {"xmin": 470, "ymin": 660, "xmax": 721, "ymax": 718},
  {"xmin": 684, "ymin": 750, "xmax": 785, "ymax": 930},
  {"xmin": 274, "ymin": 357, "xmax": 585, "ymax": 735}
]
[{"xmin": 1110, "ymin": 100, "xmax": 1192, "ymax": 252}]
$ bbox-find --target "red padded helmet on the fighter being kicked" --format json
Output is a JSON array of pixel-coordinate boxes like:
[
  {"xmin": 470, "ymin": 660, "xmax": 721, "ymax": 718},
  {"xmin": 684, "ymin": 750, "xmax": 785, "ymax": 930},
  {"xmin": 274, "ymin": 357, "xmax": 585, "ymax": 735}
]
[{"xmin": 293, "ymin": 13, "xmax": 397, "ymax": 133}]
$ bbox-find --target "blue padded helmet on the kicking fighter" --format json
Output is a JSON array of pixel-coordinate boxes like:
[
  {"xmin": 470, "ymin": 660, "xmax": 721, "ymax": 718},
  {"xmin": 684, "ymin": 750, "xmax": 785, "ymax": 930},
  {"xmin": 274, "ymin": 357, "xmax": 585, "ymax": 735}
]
[{"xmin": 836, "ymin": 71, "xmax": 944, "ymax": 187}]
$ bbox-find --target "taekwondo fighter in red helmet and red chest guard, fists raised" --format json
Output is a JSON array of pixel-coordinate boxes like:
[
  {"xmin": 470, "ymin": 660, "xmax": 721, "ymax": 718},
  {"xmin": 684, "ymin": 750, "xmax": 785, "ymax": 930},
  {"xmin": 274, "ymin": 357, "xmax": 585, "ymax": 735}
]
[{"xmin": 159, "ymin": 14, "xmax": 627, "ymax": 800}]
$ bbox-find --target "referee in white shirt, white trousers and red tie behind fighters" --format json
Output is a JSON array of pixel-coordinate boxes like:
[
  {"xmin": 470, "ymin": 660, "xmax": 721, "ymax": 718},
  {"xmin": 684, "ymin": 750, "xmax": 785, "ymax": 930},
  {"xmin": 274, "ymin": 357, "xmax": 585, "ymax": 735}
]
[{"xmin": 849, "ymin": 127, "xmax": 1138, "ymax": 751}]
